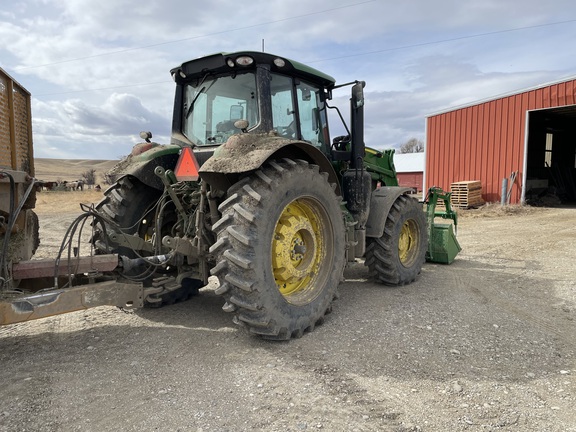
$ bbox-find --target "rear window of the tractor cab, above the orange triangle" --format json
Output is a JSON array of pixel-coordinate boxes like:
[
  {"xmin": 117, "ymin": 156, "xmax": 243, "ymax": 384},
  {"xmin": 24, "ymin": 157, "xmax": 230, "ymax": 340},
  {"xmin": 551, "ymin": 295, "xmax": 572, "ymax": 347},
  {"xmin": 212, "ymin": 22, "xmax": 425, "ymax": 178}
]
[{"xmin": 182, "ymin": 73, "xmax": 259, "ymax": 145}]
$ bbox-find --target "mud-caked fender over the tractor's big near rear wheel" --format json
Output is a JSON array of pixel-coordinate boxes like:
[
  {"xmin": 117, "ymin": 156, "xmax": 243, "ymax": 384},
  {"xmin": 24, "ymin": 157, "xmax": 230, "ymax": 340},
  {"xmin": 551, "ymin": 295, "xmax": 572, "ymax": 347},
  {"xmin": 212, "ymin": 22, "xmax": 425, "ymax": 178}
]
[{"xmin": 199, "ymin": 133, "xmax": 341, "ymax": 195}]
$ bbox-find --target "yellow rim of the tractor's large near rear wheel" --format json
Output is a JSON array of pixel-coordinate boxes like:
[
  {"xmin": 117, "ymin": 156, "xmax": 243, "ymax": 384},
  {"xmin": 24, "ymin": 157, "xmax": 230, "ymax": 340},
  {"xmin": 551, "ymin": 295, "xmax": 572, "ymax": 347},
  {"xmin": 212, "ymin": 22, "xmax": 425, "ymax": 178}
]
[{"xmin": 272, "ymin": 198, "xmax": 326, "ymax": 304}]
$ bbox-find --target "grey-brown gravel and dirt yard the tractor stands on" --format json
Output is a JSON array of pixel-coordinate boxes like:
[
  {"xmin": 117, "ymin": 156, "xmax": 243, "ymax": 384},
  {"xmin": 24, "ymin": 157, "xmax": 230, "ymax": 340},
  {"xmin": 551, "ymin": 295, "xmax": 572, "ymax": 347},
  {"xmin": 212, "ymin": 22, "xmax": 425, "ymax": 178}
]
[{"xmin": 0, "ymin": 192, "xmax": 576, "ymax": 432}]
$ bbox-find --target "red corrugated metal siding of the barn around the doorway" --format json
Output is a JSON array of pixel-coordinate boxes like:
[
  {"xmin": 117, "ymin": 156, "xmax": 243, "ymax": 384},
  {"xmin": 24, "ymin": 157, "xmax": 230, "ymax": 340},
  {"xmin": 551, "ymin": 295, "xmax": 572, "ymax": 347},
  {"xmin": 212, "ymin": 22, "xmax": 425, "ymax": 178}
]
[{"xmin": 426, "ymin": 80, "xmax": 576, "ymax": 203}]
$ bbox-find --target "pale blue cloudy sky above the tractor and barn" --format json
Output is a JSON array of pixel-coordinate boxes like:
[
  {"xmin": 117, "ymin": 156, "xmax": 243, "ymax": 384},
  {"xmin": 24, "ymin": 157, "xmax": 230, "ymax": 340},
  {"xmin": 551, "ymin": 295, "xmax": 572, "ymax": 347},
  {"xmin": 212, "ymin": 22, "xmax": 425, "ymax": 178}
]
[{"xmin": 0, "ymin": 0, "xmax": 576, "ymax": 159}]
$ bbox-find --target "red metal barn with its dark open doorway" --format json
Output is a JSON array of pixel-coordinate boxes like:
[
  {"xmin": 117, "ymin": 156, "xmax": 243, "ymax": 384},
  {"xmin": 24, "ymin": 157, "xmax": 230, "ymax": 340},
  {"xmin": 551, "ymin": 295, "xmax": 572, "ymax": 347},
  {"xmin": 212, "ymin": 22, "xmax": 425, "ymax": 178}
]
[{"xmin": 424, "ymin": 78, "xmax": 576, "ymax": 203}]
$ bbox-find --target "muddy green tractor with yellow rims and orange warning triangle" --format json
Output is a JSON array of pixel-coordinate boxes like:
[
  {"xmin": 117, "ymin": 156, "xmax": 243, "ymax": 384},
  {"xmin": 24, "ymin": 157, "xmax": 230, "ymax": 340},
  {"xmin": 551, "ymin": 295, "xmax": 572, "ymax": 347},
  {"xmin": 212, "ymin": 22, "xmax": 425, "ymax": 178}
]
[{"xmin": 93, "ymin": 52, "xmax": 459, "ymax": 340}]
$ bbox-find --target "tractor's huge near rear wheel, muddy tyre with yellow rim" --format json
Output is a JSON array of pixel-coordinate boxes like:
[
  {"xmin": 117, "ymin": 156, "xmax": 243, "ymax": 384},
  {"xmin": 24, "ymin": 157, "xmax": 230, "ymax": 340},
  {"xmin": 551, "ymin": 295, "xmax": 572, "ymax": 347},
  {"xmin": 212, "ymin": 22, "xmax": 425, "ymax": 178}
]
[{"xmin": 210, "ymin": 159, "xmax": 345, "ymax": 340}]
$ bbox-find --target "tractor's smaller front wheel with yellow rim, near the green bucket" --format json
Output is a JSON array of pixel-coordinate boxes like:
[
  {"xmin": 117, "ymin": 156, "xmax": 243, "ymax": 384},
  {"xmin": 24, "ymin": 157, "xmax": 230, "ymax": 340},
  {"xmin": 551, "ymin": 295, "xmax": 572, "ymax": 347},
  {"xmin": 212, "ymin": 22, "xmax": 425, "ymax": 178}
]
[{"xmin": 365, "ymin": 195, "xmax": 428, "ymax": 285}]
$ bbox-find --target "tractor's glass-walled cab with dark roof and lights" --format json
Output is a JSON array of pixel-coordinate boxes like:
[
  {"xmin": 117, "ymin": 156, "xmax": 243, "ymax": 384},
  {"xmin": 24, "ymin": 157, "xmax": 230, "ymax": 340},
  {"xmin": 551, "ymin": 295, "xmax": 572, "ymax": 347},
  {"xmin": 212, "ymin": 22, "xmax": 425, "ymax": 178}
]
[{"xmin": 171, "ymin": 52, "xmax": 335, "ymax": 154}]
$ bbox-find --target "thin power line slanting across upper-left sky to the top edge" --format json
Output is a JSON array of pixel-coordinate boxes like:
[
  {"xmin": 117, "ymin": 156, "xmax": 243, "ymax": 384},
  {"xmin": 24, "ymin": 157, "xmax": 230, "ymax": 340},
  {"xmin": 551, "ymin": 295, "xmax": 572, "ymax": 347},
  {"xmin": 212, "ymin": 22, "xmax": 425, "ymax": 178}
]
[{"xmin": 14, "ymin": 0, "xmax": 376, "ymax": 70}]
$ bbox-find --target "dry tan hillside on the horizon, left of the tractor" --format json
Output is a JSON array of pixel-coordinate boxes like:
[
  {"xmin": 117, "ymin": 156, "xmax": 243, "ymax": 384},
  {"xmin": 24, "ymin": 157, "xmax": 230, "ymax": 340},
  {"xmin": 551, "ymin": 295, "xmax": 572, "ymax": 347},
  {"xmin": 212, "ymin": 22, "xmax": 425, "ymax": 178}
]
[{"xmin": 34, "ymin": 158, "xmax": 118, "ymax": 182}]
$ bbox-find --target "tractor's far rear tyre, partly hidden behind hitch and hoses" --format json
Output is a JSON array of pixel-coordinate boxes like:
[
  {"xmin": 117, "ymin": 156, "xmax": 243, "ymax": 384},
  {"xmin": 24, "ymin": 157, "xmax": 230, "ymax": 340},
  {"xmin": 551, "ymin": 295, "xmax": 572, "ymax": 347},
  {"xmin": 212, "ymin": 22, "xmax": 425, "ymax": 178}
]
[{"xmin": 92, "ymin": 176, "xmax": 204, "ymax": 307}]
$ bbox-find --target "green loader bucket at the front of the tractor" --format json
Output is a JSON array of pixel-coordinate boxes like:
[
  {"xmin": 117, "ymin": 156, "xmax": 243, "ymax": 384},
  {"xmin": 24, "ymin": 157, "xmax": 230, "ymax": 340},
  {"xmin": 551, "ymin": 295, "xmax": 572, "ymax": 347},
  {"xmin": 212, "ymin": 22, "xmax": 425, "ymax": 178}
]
[{"xmin": 426, "ymin": 187, "xmax": 462, "ymax": 264}]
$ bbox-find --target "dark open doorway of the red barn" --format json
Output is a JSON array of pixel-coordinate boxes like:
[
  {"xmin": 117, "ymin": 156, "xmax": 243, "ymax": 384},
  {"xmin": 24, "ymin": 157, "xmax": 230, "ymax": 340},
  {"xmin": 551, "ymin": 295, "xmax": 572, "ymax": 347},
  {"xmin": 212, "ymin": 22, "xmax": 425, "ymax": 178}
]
[{"xmin": 524, "ymin": 105, "xmax": 576, "ymax": 206}]
